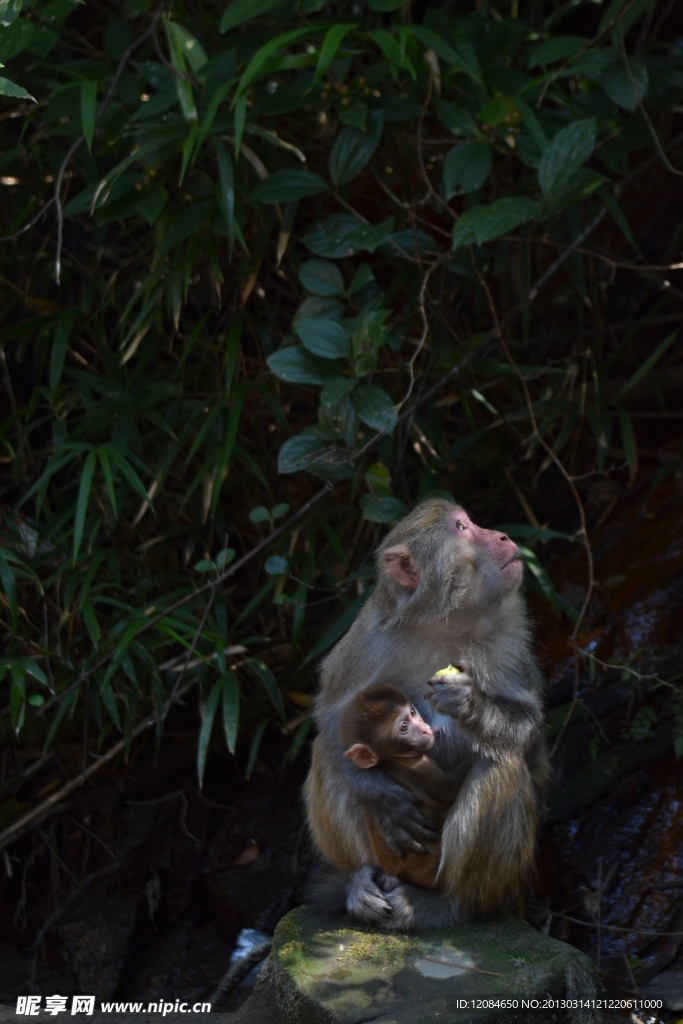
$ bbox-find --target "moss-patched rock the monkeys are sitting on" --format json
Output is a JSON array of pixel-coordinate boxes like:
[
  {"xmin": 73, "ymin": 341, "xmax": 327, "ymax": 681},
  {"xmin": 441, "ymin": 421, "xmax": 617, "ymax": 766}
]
[{"xmin": 245, "ymin": 907, "xmax": 603, "ymax": 1024}]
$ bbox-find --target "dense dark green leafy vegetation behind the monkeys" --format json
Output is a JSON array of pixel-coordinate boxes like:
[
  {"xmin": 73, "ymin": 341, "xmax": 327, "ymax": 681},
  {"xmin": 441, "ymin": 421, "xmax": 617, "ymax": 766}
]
[{"xmin": 0, "ymin": 0, "xmax": 683, "ymax": 823}]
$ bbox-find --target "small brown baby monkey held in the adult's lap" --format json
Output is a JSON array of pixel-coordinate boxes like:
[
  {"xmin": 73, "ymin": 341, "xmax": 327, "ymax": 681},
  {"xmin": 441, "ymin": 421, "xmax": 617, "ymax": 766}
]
[{"xmin": 339, "ymin": 683, "xmax": 460, "ymax": 891}]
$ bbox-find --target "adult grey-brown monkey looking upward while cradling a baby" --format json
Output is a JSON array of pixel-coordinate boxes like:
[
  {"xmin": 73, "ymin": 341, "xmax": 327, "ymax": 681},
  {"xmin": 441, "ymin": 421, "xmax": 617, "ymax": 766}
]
[{"xmin": 305, "ymin": 499, "xmax": 549, "ymax": 931}]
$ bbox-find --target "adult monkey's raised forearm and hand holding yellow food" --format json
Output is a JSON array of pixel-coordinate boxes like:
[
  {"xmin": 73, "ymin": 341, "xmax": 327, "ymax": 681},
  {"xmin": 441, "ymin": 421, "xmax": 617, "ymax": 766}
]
[{"xmin": 426, "ymin": 668, "xmax": 542, "ymax": 757}]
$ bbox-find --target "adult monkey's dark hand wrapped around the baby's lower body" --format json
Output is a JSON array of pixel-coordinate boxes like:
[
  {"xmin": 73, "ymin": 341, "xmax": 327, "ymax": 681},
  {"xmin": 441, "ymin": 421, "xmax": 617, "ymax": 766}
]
[{"xmin": 361, "ymin": 772, "xmax": 440, "ymax": 857}]
